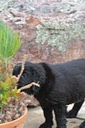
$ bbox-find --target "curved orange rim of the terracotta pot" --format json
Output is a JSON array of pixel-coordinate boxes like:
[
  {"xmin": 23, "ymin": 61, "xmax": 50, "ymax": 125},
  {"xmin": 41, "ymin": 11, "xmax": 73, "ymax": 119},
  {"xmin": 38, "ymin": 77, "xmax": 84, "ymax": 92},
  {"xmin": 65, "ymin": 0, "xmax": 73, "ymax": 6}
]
[{"xmin": 0, "ymin": 107, "xmax": 28, "ymax": 128}]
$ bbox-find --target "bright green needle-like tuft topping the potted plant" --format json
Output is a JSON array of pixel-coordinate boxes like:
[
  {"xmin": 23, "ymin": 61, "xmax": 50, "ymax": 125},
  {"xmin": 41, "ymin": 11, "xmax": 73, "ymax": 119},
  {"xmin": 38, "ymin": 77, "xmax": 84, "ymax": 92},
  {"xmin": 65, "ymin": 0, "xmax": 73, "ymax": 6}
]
[{"xmin": 0, "ymin": 21, "xmax": 20, "ymax": 61}]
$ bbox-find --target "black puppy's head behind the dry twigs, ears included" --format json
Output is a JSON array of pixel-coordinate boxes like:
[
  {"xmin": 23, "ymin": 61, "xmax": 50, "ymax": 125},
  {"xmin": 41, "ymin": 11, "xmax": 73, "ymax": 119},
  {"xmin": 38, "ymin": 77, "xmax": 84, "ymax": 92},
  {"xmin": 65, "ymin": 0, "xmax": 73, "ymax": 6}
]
[{"xmin": 13, "ymin": 62, "xmax": 46, "ymax": 94}]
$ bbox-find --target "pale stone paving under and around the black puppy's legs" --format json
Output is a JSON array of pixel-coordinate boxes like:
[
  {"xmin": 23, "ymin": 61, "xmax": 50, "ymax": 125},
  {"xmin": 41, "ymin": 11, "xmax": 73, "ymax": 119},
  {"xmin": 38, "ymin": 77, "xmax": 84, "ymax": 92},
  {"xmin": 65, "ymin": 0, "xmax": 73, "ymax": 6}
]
[{"xmin": 24, "ymin": 105, "xmax": 85, "ymax": 128}]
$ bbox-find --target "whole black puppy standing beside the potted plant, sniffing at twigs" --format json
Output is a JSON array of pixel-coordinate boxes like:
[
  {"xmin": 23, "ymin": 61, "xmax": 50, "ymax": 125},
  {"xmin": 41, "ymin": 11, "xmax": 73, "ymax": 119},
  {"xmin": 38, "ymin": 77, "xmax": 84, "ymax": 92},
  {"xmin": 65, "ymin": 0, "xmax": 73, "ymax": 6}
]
[{"xmin": 13, "ymin": 59, "xmax": 85, "ymax": 128}]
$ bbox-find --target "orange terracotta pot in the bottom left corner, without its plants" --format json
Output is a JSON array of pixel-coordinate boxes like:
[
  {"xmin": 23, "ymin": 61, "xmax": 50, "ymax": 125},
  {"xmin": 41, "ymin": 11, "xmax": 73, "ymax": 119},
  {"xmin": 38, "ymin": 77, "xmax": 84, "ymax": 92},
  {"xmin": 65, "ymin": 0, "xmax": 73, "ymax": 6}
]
[{"xmin": 0, "ymin": 108, "xmax": 28, "ymax": 128}]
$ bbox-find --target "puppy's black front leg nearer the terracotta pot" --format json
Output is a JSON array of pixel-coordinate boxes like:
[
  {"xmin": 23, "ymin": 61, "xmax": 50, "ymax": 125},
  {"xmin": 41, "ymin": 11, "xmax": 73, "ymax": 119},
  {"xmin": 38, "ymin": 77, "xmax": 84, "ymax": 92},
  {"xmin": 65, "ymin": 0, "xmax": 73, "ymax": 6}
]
[{"xmin": 39, "ymin": 107, "xmax": 53, "ymax": 128}]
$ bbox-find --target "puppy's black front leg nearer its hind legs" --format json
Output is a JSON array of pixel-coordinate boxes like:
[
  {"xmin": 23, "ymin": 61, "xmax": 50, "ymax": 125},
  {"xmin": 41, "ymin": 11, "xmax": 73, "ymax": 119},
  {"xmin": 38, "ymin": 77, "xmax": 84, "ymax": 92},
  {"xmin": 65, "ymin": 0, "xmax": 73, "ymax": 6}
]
[{"xmin": 54, "ymin": 104, "xmax": 66, "ymax": 128}]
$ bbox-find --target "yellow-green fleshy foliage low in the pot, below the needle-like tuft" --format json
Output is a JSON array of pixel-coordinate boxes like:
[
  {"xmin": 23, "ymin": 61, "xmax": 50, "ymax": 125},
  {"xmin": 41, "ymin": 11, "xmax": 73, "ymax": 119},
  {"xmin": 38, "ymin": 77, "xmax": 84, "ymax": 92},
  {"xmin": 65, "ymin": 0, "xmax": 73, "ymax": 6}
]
[{"xmin": 0, "ymin": 75, "xmax": 19, "ymax": 109}]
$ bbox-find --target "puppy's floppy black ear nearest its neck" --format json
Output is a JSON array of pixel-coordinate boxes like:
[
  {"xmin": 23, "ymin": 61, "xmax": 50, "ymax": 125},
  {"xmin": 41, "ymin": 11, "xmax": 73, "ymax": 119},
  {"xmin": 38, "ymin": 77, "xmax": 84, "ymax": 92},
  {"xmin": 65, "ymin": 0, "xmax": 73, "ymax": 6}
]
[{"xmin": 31, "ymin": 64, "xmax": 46, "ymax": 85}]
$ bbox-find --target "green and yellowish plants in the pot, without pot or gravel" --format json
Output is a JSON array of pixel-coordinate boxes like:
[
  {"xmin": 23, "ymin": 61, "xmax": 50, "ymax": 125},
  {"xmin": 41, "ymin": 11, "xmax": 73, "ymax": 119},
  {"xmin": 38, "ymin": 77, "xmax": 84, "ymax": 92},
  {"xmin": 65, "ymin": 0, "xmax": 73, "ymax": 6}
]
[{"xmin": 0, "ymin": 21, "xmax": 20, "ymax": 109}]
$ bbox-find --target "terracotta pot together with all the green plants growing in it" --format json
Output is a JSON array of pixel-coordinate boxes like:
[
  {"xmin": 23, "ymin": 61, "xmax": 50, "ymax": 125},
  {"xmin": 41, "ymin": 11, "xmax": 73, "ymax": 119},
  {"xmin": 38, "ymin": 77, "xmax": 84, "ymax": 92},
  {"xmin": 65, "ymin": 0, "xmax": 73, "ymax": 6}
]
[{"xmin": 0, "ymin": 21, "xmax": 27, "ymax": 128}]
